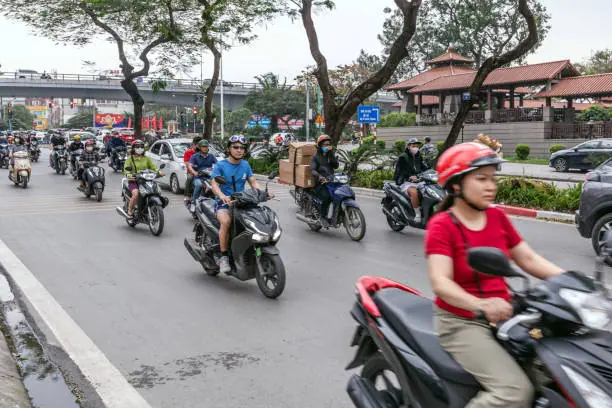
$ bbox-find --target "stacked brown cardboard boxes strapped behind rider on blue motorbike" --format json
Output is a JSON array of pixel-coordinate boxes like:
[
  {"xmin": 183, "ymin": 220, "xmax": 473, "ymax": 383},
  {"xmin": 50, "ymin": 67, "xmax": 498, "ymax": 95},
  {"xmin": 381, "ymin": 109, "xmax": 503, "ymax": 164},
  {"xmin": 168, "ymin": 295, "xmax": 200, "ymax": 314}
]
[{"xmin": 278, "ymin": 142, "xmax": 317, "ymax": 188}]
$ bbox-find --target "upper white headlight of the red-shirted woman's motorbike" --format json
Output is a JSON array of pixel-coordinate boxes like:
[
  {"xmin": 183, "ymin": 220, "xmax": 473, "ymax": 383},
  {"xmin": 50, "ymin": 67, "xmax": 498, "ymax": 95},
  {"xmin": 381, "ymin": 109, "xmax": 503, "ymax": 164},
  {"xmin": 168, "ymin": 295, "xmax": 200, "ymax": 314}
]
[{"xmin": 559, "ymin": 289, "xmax": 612, "ymax": 329}]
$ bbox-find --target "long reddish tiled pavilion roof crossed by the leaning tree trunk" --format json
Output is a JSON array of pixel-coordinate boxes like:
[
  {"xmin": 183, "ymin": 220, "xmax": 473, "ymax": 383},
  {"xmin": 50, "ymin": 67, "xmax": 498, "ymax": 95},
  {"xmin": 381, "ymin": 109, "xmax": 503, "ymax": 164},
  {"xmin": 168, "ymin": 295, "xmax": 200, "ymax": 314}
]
[{"xmin": 409, "ymin": 60, "xmax": 579, "ymax": 93}]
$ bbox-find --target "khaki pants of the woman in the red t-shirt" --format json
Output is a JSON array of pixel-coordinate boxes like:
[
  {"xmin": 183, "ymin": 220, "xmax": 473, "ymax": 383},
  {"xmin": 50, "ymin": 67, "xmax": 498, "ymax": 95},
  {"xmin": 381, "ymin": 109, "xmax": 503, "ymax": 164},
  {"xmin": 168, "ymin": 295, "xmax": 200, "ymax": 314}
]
[{"xmin": 435, "ymin": 308, "xmax": 534, "ymax": 408}]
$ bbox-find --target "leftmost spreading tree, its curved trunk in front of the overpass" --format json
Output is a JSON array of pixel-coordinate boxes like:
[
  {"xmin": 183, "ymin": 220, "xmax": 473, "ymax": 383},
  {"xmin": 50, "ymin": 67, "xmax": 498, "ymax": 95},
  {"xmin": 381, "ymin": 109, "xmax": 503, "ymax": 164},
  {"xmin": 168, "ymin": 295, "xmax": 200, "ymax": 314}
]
[{"xmin": 0, "ymin": 0, "xmax": 199, "ymax": 137}]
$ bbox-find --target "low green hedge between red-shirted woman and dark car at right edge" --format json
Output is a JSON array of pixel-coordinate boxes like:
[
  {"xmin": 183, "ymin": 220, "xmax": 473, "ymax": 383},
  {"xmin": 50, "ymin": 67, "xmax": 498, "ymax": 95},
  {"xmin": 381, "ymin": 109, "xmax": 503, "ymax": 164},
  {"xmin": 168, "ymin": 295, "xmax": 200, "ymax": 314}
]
[{"xmin": 496, "ymin": 177, "xmax": 582, "ymax": 213}]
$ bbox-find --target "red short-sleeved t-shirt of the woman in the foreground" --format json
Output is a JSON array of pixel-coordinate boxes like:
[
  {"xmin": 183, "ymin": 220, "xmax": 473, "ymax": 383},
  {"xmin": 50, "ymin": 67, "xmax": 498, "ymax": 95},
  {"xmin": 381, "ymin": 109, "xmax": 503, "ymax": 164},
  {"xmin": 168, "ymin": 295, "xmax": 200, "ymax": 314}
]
[{"xmin": 425, "ymin": 207, "xmax": 523, "ymax": 318}]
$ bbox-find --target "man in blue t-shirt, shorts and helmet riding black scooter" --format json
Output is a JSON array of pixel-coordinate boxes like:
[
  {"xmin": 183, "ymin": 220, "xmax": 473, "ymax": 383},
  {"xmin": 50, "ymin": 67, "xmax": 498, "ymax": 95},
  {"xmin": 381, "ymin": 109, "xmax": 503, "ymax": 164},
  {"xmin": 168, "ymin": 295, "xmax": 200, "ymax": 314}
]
[{"xmin": 212, "ymin": 135, "xmax": 273, "ymax": 273}]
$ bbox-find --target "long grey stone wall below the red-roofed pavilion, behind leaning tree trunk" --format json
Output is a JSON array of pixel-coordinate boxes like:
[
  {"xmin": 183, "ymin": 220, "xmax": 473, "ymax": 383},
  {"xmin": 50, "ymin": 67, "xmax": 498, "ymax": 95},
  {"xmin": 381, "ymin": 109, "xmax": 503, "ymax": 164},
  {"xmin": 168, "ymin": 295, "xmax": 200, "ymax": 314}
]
[{"xmin": 377, "ymin": 122, "xmax": 585, "ymax": 157}]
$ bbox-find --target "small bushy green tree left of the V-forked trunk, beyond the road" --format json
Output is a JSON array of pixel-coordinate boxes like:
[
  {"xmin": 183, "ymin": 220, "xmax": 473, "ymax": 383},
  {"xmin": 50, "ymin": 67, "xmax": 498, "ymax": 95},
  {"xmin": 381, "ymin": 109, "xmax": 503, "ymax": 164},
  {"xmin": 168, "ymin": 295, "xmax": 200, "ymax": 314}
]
[{"xmin": 244, "ymin": 72, "xmax": 306, "ymax": 132}]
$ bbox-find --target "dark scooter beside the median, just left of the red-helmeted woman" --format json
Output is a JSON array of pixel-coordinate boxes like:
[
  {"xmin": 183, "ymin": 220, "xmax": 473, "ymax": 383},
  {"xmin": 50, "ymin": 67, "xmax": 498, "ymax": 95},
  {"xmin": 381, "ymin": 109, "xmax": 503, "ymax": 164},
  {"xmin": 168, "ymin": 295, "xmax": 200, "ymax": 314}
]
[{"xmin": 381, "ymin": 170, "xmax": 446, "ymax": 232}]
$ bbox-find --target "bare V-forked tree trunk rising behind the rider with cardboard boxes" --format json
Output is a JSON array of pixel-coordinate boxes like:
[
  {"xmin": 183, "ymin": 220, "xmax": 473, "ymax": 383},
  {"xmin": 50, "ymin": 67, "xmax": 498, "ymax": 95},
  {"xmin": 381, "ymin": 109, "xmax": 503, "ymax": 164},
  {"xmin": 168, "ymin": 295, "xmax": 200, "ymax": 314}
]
[{"xmin": 288, "ymin": 0, "xmax": 421, "ymax": 144}]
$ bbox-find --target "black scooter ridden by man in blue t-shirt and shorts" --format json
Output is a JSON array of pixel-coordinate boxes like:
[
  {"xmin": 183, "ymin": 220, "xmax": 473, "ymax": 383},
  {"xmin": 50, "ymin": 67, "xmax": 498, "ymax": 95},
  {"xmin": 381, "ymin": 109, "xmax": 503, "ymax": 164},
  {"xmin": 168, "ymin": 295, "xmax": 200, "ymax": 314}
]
[{"xmin": 184, "ymin": 173, "xmax": 286, "ymax": 299}]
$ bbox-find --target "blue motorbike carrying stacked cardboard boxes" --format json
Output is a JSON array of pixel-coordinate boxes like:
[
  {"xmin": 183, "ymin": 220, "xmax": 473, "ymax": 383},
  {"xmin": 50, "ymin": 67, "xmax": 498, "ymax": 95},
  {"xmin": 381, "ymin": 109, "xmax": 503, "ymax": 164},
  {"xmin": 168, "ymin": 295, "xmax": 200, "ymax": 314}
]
[{"xmin": 290, "ymin": 174, "xmax": 366, "ymax": 241}]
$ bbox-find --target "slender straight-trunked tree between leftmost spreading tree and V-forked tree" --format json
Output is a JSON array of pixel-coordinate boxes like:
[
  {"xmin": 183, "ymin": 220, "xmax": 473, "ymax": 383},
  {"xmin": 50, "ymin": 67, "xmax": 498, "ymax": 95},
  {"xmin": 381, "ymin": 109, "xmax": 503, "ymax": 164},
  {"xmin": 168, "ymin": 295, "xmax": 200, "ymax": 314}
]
[{"xmin": 198, "ymin": 0, "xmax": 279, "ymax": 139}]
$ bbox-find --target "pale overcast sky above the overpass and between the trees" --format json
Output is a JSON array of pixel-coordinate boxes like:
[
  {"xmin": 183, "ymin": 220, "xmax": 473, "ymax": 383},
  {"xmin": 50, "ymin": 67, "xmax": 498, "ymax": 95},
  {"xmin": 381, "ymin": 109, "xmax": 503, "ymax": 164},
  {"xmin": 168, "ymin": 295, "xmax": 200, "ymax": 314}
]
[{"xmin": 0, "ymin": 0, "xmax": 612, "ymax": 83}]
